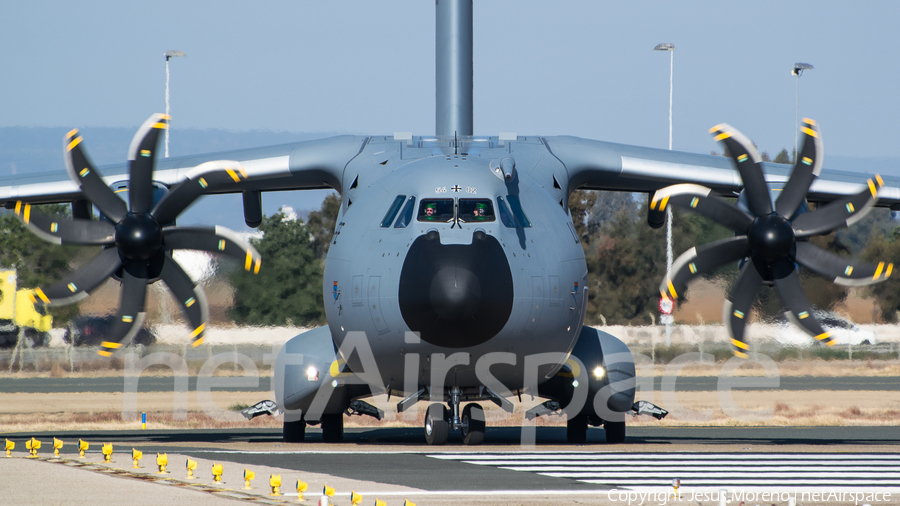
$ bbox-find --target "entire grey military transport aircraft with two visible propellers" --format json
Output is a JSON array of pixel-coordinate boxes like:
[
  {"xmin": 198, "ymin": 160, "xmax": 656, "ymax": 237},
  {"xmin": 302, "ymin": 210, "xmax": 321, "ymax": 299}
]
[{"xmin": 0, "ymin": 0, "xmax": 900, "ymax": 444}]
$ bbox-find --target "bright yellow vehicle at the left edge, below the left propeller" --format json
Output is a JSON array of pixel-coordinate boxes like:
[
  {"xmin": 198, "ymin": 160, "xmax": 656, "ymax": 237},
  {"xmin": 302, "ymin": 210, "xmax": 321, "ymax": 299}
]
[{"xmin": 0, "ymin": 270, "xmax": 53, "ymax": 348}]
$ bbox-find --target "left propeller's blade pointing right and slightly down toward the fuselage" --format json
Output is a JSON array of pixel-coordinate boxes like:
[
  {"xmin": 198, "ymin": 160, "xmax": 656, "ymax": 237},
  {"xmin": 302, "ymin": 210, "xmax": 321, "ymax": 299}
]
[{"xmin": 163, "ymin": 226, "xmax": 262, "ymax": 274}]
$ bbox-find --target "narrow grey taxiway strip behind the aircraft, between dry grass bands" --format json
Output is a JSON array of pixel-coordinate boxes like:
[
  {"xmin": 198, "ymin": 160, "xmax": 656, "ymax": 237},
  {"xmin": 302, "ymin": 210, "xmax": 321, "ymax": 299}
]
[{"xmin": 0, "ymin": 376, "xmax": 900, "ymax": 393}]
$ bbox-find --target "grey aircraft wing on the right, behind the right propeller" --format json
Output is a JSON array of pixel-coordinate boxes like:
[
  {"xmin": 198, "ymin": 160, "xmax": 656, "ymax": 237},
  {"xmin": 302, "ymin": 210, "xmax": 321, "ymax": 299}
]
[{"xmin": 543, "ymin": 136, "xmax": 900, "ymax": 210}]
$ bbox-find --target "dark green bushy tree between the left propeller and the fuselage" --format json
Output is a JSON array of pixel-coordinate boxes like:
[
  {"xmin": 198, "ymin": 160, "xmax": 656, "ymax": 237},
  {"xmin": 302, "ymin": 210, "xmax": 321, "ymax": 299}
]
[{"xmin": 229, "ymin": 208, "xmax": 327, "ymax": 325}]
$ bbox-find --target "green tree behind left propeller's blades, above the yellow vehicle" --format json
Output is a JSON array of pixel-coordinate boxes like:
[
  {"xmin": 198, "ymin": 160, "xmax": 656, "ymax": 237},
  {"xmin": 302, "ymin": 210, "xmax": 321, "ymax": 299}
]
[{"xmin": 0, "ymin": 204, "xmax": 83, "ymax": 326}]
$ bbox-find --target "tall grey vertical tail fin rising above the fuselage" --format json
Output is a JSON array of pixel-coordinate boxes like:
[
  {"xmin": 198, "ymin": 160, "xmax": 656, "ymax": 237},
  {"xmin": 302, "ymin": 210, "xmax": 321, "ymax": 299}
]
[{"xmin": 434, "ymin": 0, "xmax": 473, "ymax": 137}]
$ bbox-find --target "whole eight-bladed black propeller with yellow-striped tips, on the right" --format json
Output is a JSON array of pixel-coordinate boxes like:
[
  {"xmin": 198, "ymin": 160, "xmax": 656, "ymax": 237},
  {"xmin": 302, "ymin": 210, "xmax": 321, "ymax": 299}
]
[{"xmin": 648, "ymin": 118, "xmax": 894, "ymax": 358}]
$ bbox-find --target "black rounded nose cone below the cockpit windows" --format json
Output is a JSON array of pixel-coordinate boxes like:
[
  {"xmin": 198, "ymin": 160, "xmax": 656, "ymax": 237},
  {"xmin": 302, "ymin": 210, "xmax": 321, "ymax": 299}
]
[{"xmin": 398, "ymin": 232, "xmax": 513, "ymax": 348}]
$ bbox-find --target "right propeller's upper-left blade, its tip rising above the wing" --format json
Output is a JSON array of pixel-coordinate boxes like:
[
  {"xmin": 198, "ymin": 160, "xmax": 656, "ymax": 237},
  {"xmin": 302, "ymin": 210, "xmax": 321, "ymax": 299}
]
[{"xmin": 709, "ymin": 123, "xmax": 772, "ymax": 216}]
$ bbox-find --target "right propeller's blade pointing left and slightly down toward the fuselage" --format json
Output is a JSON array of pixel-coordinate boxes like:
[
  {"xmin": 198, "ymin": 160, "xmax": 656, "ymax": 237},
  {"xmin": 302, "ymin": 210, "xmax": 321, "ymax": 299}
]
[{"xmin": 659, "ymin": 235, "xmax": 750, "ymax": 300}]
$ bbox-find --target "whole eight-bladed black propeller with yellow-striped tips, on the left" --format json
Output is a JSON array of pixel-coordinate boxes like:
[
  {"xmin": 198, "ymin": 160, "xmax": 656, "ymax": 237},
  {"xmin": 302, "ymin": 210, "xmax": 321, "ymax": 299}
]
[{"xmin": 15, "ymin": 114, "xmax": 261, "ymax": 357}]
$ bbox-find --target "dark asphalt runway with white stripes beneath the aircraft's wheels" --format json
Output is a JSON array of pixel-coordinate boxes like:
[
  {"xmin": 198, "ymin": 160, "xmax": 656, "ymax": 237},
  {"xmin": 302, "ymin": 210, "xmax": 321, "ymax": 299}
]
[{"xmin": 4, "ymin": 427, "xmax": 900, "ymax": 491}]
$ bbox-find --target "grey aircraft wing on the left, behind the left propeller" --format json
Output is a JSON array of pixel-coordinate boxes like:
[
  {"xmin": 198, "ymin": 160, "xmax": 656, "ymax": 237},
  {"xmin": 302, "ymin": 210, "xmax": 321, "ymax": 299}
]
[{"xmin": 0, "ymin": 135, "xmax": 368, "ymax": 208}]
